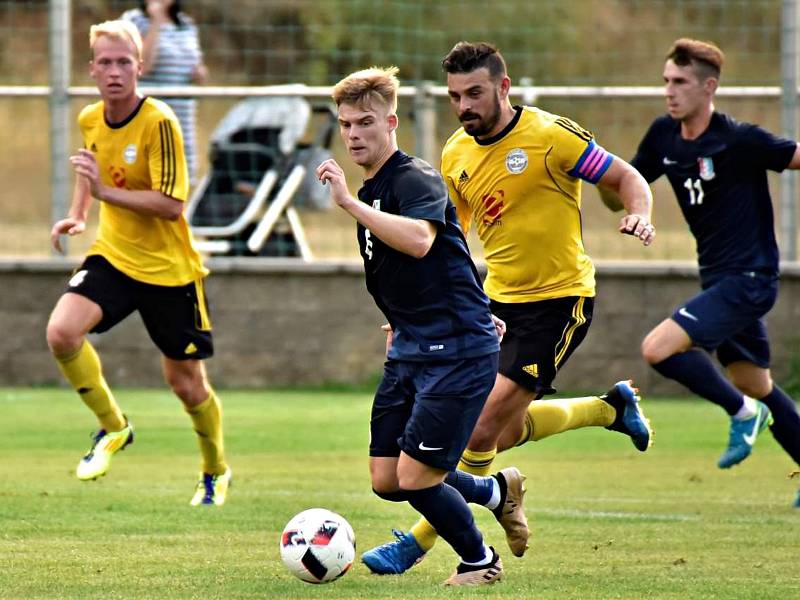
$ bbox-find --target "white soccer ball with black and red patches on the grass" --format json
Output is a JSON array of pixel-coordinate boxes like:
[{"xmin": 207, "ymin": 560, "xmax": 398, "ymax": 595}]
[{"xmin": 280, "ymin": 508, "xmax": 356, "ymax": 583}]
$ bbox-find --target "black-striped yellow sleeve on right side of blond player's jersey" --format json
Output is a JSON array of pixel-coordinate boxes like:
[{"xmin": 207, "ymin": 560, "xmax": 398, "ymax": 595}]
[{"xmin": 149, "ymin": 118, "xmax": 189, "ymax": 201}]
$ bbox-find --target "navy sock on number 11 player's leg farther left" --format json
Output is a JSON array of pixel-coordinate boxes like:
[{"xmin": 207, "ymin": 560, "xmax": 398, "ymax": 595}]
[{"xmin": 651, "ymin": 348, "xmax": 744, "ymax": 416}]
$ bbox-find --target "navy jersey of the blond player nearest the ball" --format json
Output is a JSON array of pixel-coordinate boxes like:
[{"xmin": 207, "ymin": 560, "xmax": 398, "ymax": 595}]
[{"xmin": 358, "ymin": 150, "xmax": 500, "ymax": 360}]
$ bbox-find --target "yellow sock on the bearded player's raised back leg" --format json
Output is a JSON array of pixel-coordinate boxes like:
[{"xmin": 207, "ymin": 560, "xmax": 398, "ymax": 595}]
[{"xmin": 517, "ymin": 396, "xmax": 617, "ymax": 446}]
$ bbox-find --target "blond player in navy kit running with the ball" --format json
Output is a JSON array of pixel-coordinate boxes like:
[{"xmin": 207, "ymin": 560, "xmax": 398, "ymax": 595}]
[{"xmin": 317, "ymin": 67, "xmax": 528, "ymax": 585}]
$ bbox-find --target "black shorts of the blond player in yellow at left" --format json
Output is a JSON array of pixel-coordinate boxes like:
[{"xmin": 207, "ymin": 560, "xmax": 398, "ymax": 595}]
[{"xmin": 67, "ymin": 254, "xmax": 214, "ymax": 360}]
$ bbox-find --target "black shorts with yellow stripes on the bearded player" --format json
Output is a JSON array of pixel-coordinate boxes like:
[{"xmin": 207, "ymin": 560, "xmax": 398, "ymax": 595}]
[{"xmin": 491, "ymin": 296, "xmax": 594, "ymax": 395}]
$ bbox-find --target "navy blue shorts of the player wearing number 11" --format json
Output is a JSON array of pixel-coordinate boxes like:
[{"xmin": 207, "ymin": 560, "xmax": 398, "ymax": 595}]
[{"xmin": 672, "ymin": 272, "xmax": 778, "ymax": 369}]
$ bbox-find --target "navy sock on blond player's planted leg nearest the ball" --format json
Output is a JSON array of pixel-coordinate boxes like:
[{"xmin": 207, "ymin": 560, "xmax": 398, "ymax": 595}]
[{"xmin": 403, "ymin": 483, "xmax": 485, "ymax": 563}]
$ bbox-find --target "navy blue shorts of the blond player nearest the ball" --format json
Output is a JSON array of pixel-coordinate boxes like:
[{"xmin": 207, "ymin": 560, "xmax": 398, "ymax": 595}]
[{"xmin": 369, "ymin": 353, "xmax": 498, "ymax": 471}]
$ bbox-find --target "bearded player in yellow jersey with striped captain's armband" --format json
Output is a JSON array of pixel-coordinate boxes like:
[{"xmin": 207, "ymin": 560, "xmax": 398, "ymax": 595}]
[{"xmin": 362, "ymin": 42, "xmax": 655, "ymax": 574}]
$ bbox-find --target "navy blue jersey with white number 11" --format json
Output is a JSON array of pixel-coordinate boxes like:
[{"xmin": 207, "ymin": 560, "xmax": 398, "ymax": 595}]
[{"xmin": 631, "ymin": 112, "xmax": 796, "ymax": 284}]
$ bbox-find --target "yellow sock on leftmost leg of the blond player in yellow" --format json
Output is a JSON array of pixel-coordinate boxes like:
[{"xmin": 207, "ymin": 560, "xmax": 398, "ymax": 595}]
[{"xmin": 55, "ymin": 340, "xmax": 126, "ymax": 431}]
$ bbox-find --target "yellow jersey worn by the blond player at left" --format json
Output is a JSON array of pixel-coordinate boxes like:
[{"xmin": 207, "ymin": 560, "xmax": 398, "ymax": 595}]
[{"xmin": 78, "ymin": 98, "xmax": 208, "ymax": 286}]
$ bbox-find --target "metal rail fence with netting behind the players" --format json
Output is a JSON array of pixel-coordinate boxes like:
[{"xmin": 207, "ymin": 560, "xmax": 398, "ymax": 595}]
[{"xmin": 0, "ymin": 0, "xmax": 798, "ymax": 259}]
